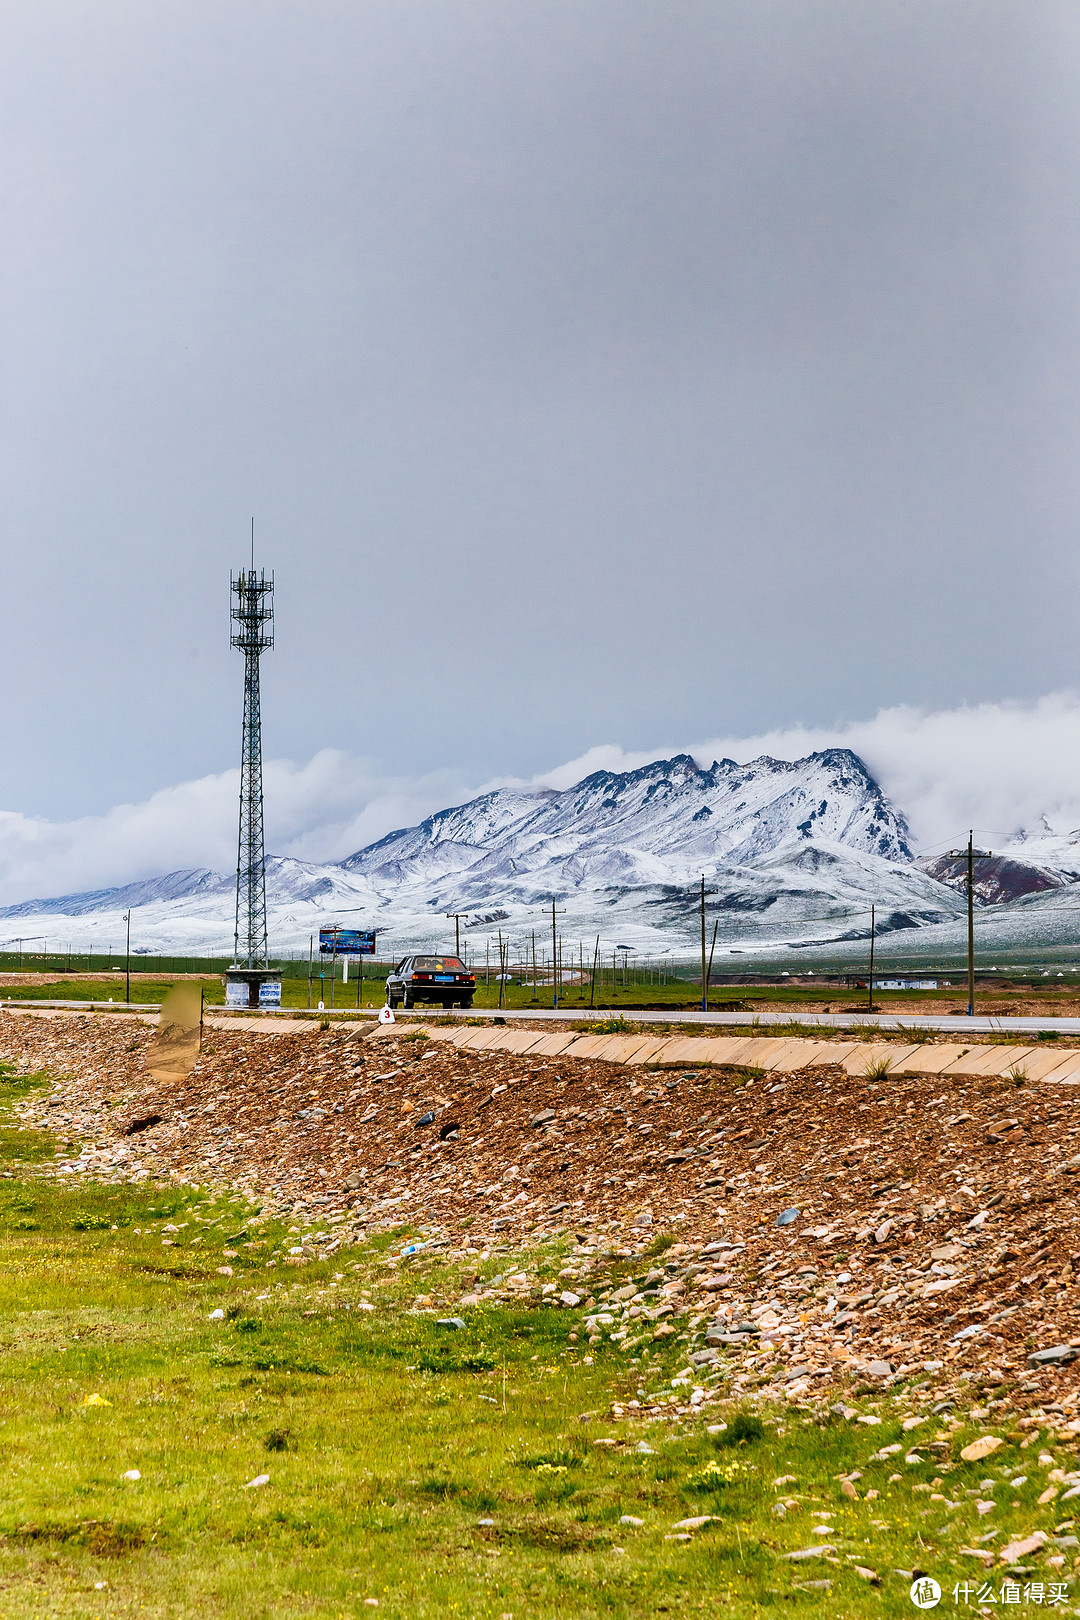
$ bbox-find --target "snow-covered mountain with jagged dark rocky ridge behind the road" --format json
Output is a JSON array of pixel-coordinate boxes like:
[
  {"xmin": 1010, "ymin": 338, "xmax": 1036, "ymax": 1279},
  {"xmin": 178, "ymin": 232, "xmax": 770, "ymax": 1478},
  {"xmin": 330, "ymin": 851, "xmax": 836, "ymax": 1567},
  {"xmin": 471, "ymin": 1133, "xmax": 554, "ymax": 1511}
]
[{"xmin": 0, "ymin": 748, "xmax": 963, "ymax": 954}]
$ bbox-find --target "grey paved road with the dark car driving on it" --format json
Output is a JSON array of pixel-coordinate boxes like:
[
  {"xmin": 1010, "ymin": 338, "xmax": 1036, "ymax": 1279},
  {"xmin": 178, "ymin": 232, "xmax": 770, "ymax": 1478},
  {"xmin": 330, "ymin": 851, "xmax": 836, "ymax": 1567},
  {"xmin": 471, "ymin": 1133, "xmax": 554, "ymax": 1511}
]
[{"xmin": 3, "ymin": 996, "xmax": 1080, "ymax": 1037}]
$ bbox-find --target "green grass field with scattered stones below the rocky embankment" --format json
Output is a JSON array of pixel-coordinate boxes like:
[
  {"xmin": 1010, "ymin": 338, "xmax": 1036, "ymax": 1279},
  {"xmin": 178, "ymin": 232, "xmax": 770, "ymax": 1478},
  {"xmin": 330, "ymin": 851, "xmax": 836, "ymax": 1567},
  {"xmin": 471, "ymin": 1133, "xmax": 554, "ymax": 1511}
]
[{"xmin": 0, "ymin": 1076, "xmax": 1075, "ymax": 1620}]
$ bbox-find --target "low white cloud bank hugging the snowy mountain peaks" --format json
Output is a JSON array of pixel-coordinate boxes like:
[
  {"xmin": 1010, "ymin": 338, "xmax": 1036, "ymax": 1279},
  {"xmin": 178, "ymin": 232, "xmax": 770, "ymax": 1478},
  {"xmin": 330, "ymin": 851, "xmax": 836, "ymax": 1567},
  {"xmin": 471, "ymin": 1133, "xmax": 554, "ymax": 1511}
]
[{"xmin": 0, "ymin": 692, "xmax": 1080, "ymax": 904}]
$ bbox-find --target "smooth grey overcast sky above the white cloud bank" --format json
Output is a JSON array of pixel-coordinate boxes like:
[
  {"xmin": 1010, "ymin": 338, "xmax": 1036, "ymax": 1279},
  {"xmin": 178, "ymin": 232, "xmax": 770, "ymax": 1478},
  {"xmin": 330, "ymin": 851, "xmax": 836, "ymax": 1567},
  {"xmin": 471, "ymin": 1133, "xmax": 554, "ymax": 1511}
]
[{"xmin": 0, "ymin": 0, "xmax": 1080, "ymax": 893}]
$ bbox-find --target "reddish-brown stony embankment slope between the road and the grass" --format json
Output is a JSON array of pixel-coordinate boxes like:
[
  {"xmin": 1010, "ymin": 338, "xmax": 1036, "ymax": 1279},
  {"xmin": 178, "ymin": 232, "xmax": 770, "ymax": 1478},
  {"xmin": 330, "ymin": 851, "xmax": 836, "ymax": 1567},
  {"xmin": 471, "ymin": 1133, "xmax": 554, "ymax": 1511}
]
[{"xmin": 0, "ymin": 1013, "xmax": 1080, "ymax": 1434}]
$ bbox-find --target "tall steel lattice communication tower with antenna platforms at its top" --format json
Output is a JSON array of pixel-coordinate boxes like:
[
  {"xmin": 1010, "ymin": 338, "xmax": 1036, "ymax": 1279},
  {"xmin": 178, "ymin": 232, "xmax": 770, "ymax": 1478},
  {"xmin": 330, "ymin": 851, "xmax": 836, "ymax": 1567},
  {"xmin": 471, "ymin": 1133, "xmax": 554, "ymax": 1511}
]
[{"xmin": 230, "ymin": 564, "xmax": 274, "ymax": 969}]
